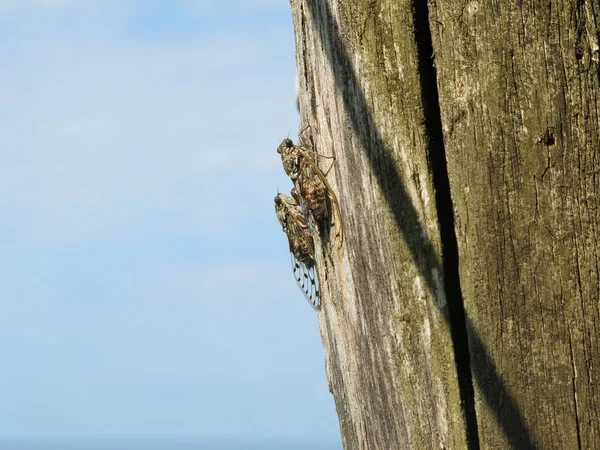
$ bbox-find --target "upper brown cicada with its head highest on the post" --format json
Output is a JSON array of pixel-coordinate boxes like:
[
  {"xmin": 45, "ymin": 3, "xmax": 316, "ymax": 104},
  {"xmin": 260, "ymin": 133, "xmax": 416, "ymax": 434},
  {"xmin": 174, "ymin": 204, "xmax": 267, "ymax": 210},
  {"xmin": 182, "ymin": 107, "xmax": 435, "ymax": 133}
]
[{"xmin": 277, "ymin": 128, "xmax": 343, "ymax": 245}]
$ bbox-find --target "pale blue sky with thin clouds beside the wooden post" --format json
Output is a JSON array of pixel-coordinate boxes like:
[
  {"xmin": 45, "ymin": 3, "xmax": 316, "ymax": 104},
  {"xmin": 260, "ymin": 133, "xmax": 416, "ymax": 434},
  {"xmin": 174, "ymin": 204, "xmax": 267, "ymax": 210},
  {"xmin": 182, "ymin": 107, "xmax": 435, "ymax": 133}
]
[{"xmin": 0, "ymin": 0, "xmax": 339, "ymax": 439}]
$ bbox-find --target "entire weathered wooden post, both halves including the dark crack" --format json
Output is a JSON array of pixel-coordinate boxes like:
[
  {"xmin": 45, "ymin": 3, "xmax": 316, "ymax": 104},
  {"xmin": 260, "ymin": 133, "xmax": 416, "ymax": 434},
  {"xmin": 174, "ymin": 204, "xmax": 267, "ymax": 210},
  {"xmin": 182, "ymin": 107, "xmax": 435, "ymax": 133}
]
[{"xmin": 291, "ymin": 0, "xmax": 600, "ymax": 450}]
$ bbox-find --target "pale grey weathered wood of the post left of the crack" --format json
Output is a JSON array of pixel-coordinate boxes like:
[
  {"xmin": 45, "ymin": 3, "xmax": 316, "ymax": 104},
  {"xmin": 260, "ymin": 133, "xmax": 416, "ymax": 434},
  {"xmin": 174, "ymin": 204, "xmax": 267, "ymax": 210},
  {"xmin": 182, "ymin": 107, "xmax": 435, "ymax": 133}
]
[{"xmin": 291, "ymin": 0, "xmax": 466, "ymax": 450}]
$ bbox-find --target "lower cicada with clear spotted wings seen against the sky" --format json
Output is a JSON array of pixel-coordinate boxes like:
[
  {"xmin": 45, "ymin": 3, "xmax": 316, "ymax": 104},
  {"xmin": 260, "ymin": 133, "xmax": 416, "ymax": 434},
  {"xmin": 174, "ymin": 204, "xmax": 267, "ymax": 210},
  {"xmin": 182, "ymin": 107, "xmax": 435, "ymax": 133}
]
[{"xmin": 275, "ymin": 193, "xmax": 321, "ymax": 311}]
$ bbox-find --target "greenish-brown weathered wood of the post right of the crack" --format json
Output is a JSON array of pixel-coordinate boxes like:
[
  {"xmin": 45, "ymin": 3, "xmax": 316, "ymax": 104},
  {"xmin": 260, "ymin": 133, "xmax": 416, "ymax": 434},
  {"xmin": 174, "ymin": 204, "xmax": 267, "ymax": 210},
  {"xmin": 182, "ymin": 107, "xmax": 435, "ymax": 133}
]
[{"xmin": 430, "ymin": 0, "xmax": 600, "ymax": 449}]
